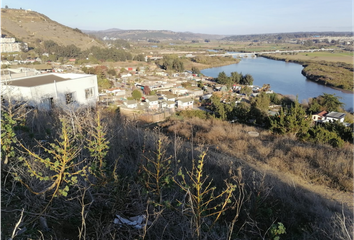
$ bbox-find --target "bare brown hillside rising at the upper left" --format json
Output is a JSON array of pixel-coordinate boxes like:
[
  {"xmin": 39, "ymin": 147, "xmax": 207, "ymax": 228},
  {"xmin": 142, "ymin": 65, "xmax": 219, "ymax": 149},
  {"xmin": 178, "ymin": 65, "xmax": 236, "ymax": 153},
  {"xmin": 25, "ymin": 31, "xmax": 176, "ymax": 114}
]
[{"xmin": 0, "ymin": 8, "xmax": 103, "ymax": 50}]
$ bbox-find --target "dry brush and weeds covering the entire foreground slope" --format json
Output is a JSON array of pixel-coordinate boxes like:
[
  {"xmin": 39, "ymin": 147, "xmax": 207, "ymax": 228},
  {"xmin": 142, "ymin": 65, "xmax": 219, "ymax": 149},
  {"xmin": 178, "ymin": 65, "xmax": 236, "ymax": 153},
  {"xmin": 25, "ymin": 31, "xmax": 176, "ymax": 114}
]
[{"xmin": 0, "ymin": 103, "xmax": 353, "ymax": 240}]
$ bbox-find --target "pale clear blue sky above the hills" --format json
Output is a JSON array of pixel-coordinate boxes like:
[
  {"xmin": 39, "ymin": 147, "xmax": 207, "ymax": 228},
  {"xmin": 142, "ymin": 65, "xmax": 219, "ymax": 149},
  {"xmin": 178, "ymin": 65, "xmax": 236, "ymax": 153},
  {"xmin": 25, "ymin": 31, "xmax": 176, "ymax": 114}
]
[{"xmin": 0, "ymin": 0, "xmax": 354, "ymax": 35}]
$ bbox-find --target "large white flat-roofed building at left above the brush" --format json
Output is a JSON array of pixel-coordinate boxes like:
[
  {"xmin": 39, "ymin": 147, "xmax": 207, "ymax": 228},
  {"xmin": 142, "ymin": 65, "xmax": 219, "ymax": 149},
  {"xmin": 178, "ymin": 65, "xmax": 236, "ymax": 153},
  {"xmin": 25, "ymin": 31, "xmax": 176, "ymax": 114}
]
[{"xmin": 0, "ymin": 73, "xmax": 98, "ymax": 110}]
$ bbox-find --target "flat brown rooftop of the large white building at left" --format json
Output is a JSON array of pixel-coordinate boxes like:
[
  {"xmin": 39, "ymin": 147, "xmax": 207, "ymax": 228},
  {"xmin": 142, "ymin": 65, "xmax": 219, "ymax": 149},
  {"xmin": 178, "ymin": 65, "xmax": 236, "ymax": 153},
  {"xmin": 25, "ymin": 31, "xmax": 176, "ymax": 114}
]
[{"xmin": 3, "ymin": 74, "xmax": 71, "ymax": 87}]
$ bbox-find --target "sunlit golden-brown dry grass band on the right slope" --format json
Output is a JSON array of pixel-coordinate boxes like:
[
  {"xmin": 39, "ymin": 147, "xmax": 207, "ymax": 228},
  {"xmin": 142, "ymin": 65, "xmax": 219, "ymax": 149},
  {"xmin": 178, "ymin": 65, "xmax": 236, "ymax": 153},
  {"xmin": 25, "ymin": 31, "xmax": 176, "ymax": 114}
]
[{"xmin": 167, "ymin": 116, "xmax": 354, "ymax": 197}]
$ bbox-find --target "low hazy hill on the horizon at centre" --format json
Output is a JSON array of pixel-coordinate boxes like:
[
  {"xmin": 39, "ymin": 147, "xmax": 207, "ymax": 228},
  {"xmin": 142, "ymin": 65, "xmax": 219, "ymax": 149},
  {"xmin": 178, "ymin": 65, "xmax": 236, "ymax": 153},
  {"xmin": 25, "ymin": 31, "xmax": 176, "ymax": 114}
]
[{"xmin": 84, "ymin": 28, "xmax": 225, "ymax": 41}]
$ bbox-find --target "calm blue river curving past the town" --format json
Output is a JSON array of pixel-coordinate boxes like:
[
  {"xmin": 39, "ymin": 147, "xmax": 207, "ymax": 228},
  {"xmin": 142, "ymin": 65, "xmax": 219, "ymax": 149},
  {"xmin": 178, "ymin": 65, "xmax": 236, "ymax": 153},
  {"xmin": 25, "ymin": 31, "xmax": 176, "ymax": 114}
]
[{"xmin": 201, "ymin": 57, "xmax": 354, "ymax": 111}]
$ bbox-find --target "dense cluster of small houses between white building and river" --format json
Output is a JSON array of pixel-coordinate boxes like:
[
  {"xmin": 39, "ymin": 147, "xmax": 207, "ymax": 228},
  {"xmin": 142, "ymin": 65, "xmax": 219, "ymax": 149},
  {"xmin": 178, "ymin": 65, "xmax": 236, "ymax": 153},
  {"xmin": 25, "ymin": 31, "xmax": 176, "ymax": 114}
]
[{"xmin": 100, "ymin": 67, "xmax": 205, "ymax": 112}]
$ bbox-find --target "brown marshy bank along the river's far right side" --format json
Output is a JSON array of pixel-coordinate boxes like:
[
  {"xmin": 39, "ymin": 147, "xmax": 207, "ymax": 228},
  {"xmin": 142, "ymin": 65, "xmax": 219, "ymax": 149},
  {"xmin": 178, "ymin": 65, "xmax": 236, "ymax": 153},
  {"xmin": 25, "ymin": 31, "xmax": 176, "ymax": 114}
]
[{"xmin": 260, "ymin": 55, "xmax": 354, "ymax": 93}]
